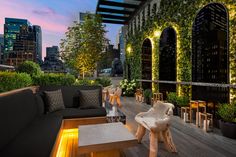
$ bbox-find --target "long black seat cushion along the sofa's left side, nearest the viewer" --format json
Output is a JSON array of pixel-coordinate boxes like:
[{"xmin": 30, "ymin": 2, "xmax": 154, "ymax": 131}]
[{"xmin": 0, "ymin": 115, "xmax": 62, "ymax": 157}]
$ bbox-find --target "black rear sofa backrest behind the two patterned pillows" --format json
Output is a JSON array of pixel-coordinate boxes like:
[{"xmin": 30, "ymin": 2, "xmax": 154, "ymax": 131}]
[{"xmin": 38, "ymin": 86, "xmax": 102, "ymax": 108}]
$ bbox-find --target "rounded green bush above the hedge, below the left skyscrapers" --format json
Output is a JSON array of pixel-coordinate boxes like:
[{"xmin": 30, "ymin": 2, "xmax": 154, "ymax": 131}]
[{"xmin": 17, "ymin": 61, "xmax": 42, "ymax": 76}]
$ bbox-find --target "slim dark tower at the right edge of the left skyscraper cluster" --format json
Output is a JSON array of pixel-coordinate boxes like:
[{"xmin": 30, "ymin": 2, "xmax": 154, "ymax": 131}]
[{"xmin": 33, "ymin": 25, "xmax": 42, "ymax": 63}]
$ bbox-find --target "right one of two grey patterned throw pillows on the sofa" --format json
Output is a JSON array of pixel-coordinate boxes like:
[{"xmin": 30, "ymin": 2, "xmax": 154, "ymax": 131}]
[{"xmin": 79, "ymin": 89, "xmax": 100, "ymax": 108}]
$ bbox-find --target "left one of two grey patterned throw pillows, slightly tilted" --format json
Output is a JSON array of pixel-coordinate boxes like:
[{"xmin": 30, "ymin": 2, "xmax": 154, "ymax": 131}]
[{"xmin": 44, "ymin": 89, "xmax": 65, "ymax": 112}]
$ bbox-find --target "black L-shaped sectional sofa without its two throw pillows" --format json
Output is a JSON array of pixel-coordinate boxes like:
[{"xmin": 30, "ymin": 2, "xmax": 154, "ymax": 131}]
[{"xmin": 0, "ymin": 86, "xmax": 106, "ymax": 157}]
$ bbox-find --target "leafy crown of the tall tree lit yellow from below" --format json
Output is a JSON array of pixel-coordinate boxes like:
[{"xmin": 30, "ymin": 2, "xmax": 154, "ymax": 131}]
[{"xmin": 60, "ymin": 14, "xmax": 106, "ymax": 78}]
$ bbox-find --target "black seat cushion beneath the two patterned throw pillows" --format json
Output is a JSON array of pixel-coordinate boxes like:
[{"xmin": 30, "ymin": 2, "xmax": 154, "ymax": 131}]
[{"xmin": 49, "ymin": 107, "xmax": 106, "ymax": 119}]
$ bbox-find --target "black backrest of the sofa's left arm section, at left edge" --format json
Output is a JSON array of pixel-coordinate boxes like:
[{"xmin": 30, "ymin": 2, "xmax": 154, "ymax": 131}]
[{"xmin": 0, "ymin": 89, "xmax": 37, "ymax": 151}]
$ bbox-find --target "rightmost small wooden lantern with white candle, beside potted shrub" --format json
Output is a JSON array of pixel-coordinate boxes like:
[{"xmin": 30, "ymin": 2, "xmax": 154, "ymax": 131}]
[{"xmin": 199, "ymin": 112, "xmax": 213, "ymax": 132}]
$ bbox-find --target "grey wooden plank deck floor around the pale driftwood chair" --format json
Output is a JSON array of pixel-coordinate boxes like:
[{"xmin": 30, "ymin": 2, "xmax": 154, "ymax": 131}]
[{"xmin": 122, "ymin": 97, "xmax": 236, "ymax": 157}]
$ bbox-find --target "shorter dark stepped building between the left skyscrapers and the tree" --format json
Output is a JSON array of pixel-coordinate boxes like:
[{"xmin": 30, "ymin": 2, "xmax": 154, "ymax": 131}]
[{"xmin": 41, "ymin": 46, "xmax": 65, "ymax": 72}]
